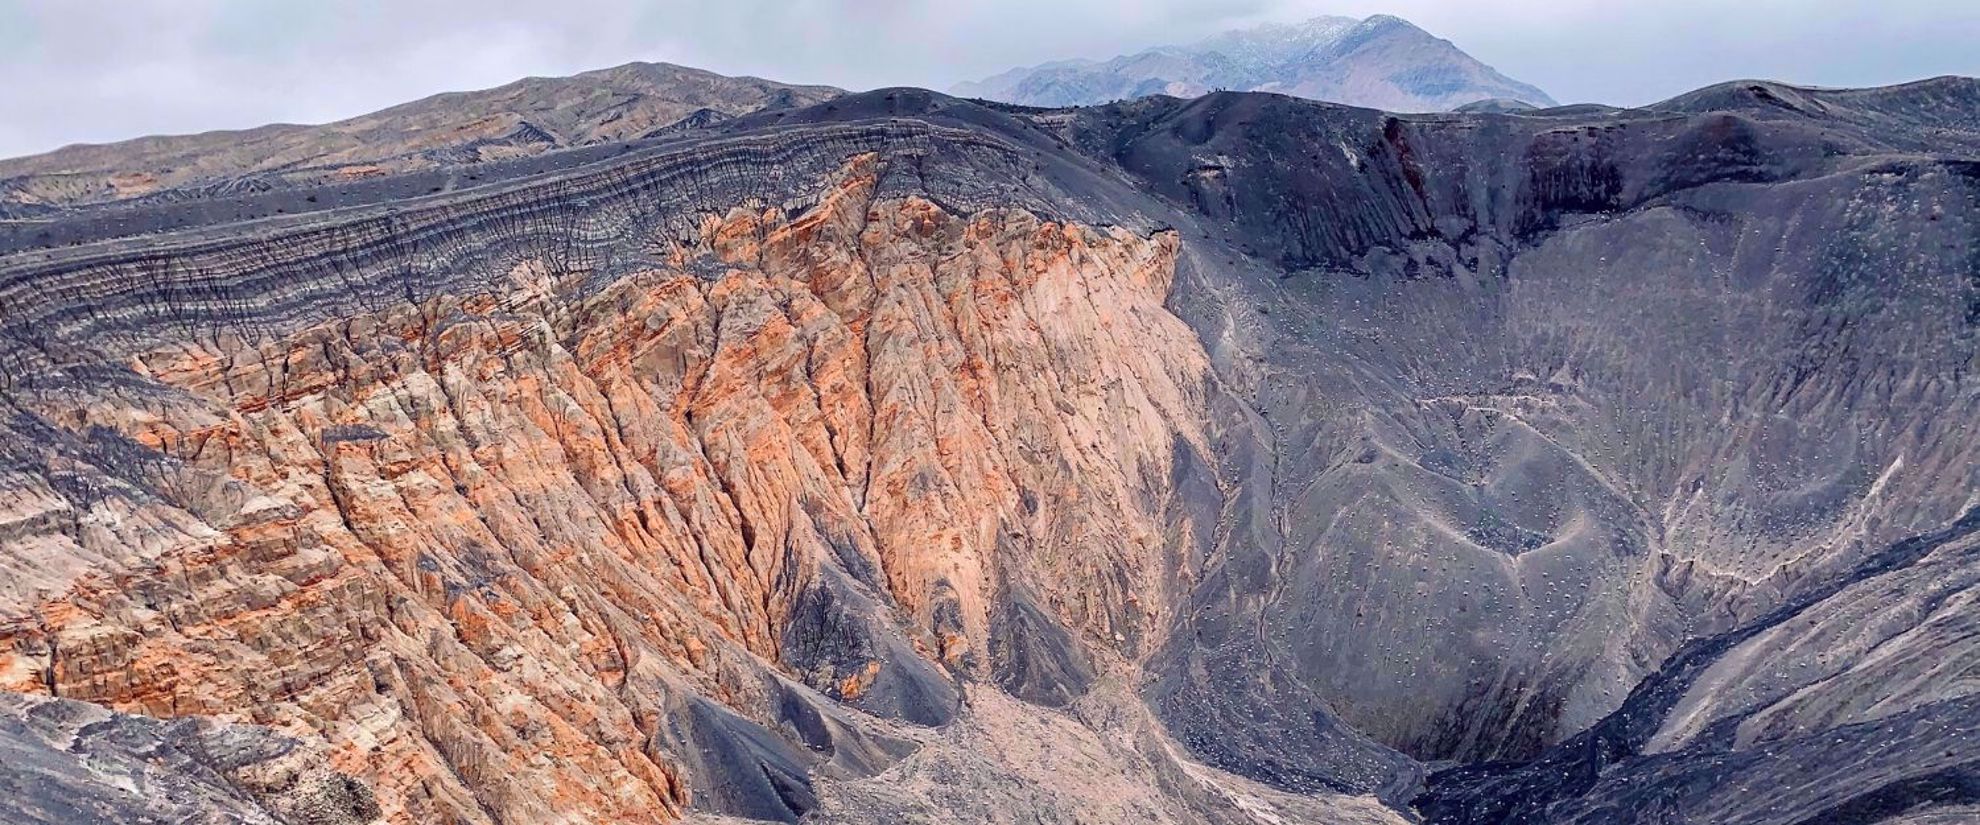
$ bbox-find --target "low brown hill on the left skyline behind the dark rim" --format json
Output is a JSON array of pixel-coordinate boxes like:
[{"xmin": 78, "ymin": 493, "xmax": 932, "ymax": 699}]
[{"xmin": 0, "ymin": 63, "xmax": 843, "ymax": 216}]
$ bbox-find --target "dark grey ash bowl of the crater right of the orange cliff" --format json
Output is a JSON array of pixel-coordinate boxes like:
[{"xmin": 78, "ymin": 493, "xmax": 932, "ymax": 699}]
[{"xmin": 1069, "ymin": 81, "xmax": 1980, "ymax": 772}]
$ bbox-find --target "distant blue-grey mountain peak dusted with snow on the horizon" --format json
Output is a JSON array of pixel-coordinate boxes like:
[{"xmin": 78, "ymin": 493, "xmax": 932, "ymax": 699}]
[{"xmin": 954, "ymin": 14, "xmax": 1554, "ymax": 111}]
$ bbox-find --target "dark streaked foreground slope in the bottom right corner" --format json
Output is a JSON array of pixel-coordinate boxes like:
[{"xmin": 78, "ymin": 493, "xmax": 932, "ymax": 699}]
[{"xmin": 1416, "ymin": 510, "xmax": 1980, "ymax": 825}]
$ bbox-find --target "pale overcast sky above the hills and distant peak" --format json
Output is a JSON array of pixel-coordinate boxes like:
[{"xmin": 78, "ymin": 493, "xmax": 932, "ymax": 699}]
[{"xmin": 0, "ymin": 0, "xmax": 1980, "ymax": 156}]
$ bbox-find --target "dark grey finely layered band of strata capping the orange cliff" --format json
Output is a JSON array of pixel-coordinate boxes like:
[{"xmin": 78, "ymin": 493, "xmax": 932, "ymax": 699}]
[{"xmin": 0, "ymin": 123, "xmax": 1077, "ymax": 382}]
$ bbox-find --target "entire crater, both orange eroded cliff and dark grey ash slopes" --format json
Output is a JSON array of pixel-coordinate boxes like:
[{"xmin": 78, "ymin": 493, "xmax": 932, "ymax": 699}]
[{"xmin": 0, "ymin": 77, "xmax": 1980, "ymax": 825}]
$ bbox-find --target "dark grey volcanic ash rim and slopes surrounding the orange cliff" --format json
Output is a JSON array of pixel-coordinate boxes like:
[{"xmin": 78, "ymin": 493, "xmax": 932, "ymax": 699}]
[{"xmin": 0, "ymin": 79, "xmax": 1980, "ymax": 825}]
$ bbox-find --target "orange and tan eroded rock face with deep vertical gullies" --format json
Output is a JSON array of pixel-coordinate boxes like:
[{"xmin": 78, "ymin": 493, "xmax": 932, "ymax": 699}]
[{"xmin": 4, "ymin": 149, "xmax": 1243, "ymax": 821}]
